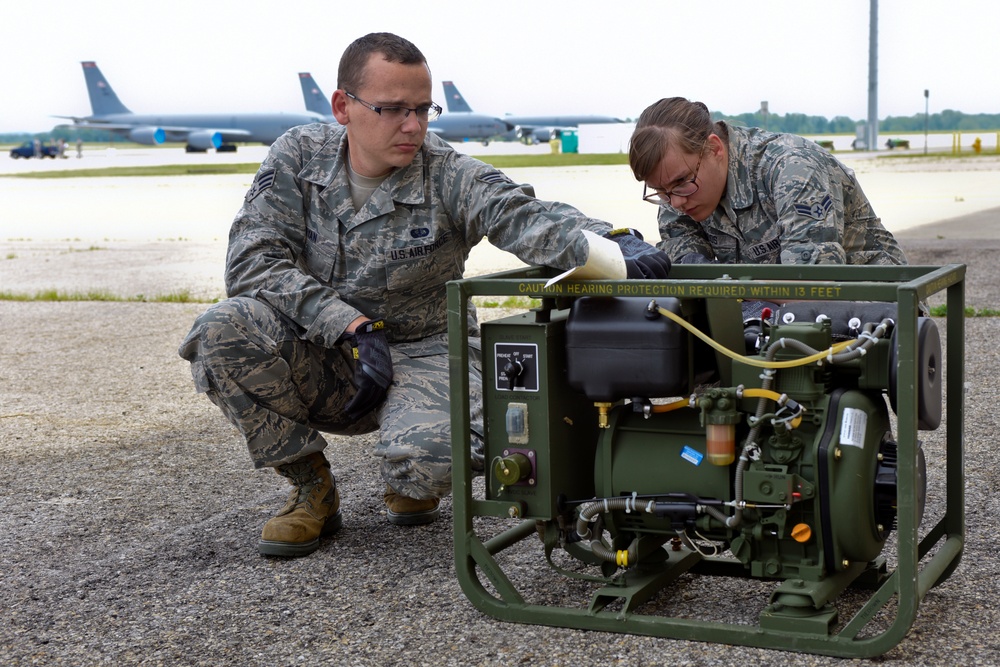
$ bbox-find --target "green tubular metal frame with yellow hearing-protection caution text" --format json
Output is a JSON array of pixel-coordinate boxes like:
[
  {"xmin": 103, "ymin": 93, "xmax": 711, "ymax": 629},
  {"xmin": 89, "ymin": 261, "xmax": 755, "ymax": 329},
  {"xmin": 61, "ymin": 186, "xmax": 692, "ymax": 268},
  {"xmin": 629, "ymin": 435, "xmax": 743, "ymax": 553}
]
[{"xmin": 448, "ymin": 264, "xmax": 966, "ymax": 657}]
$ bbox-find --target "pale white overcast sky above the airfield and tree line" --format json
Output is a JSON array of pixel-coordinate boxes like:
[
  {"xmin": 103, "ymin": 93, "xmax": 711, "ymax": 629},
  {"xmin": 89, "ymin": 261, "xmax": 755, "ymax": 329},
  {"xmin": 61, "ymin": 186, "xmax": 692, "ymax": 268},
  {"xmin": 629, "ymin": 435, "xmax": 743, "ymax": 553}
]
[{"xmin": 0, "ymin": 0, "xmax": 1000, "ymax": 132}]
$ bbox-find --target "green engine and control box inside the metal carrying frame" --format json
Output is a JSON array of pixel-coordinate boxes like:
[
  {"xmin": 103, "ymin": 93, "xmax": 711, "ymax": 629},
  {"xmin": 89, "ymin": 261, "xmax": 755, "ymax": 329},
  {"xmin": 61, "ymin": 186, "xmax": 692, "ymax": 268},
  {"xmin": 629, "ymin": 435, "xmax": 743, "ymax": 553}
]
[{"xmin": 483, "ymin": 296, "xmax": 941, "ymax": 632}]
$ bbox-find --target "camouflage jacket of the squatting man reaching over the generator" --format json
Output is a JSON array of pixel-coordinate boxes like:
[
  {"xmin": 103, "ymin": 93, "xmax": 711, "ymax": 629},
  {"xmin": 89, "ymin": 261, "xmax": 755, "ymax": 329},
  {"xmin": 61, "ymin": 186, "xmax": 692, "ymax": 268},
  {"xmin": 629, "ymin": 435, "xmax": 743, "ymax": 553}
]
[{"xmin": 226, "ymin": 124, "xmax": 610, "ymax": 347}]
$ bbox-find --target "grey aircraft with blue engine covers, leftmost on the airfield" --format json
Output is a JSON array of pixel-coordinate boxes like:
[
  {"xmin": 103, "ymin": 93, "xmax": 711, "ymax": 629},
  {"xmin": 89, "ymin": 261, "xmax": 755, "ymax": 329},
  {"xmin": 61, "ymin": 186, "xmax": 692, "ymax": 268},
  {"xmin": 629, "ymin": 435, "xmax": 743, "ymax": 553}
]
[{"xmin": 60, "ymin": 61, "xmax": 325, "ymax": 152}]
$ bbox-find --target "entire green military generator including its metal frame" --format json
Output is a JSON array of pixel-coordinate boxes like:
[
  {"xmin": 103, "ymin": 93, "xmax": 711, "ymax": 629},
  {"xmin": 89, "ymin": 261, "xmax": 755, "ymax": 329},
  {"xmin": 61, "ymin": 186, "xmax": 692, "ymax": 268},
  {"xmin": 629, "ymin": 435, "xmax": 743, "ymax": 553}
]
[{"xmin": 448, "ymin": 265, "xmax": 965, "ymax": 657}]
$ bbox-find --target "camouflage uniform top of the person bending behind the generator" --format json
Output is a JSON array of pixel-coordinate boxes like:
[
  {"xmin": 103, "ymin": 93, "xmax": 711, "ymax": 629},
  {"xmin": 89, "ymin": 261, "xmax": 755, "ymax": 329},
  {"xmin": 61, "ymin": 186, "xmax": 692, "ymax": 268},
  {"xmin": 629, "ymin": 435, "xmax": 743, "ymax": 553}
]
[{"xmin": 657, "ymin": 126, "xmax": 906, "ymax": 264}]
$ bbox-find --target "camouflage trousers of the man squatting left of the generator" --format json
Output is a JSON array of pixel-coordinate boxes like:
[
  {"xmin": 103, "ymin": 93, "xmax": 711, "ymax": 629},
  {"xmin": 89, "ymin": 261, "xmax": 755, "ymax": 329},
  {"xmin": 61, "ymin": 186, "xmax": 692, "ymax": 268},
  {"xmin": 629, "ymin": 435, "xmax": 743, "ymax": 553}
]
[{"xmin": 178, "ymin": 297, "xmax": 483, "ymax": 498}]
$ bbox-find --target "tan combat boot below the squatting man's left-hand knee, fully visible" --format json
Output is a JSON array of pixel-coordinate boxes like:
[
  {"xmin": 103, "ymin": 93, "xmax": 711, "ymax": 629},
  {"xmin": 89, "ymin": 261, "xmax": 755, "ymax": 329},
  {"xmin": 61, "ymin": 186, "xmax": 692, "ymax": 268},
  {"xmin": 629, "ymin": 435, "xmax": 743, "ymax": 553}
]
[{"xmin": 257, "ymin": 452, "xmax": 343, "ymax": 558}]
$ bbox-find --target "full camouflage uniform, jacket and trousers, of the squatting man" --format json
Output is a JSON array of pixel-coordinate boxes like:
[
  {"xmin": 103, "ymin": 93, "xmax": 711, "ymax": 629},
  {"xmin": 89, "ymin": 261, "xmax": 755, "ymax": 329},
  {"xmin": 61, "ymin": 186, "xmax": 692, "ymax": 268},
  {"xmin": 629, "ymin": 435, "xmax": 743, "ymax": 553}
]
[{"xmin": 179, "ymin": 124, "xmax": 610, "ymax": 498}]
